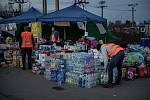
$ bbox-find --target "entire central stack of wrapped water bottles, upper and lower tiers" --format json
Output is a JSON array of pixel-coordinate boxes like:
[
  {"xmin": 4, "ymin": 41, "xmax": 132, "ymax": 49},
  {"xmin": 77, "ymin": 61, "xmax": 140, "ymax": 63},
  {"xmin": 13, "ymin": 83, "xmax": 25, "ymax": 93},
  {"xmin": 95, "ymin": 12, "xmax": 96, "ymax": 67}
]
[{"xmin": 62, "ymin": 52, "xmax": 101, "ymax": 88}]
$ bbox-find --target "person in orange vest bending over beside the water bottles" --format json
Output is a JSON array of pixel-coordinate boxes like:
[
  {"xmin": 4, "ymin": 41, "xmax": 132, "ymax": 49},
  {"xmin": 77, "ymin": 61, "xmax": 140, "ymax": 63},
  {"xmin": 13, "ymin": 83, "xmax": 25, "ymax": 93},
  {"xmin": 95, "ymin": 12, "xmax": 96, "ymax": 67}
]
[{"xmin": 97, "ymin": 43, "xmax": 125, "ymax": 88}]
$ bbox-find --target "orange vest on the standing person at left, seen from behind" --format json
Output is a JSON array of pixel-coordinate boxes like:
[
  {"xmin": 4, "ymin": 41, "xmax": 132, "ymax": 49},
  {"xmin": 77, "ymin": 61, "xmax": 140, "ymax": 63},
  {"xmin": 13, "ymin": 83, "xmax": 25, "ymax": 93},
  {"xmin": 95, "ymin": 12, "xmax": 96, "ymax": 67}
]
[{"xmin": 21, "ymin": 32, "xmax": 33, "ymax": 48}]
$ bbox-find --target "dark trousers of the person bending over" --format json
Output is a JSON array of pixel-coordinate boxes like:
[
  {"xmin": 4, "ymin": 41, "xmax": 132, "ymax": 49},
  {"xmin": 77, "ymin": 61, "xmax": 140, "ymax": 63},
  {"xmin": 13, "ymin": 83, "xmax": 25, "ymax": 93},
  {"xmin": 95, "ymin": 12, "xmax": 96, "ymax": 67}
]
[{"xmin": 108, "ymin": 51, "xmax": 124, "ymax": 84}]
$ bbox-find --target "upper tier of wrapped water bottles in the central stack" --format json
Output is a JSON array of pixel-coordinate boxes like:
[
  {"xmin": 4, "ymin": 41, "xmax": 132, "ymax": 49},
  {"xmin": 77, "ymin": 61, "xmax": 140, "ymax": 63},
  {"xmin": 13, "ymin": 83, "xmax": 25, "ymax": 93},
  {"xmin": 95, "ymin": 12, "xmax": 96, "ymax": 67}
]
[{"xmin": 62, "ymin": 52, "xmax": 95, "ymax": 73}]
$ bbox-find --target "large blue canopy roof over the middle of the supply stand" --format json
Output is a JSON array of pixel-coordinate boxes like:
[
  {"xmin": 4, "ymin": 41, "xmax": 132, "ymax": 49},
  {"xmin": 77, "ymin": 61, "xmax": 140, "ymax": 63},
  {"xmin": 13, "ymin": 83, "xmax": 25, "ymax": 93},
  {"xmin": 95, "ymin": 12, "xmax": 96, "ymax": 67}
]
[{"xmin": 38, "ymin": 5, "xmax": 107, "ymax": 23}]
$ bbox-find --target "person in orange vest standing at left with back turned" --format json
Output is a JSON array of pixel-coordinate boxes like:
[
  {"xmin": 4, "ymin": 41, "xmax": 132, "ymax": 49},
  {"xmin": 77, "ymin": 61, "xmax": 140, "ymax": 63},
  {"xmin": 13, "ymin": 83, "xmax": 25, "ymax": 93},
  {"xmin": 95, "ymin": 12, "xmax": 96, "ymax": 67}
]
[{"xmin": 21, "ymin": 26, "xmax": 35, "ymax": 70}]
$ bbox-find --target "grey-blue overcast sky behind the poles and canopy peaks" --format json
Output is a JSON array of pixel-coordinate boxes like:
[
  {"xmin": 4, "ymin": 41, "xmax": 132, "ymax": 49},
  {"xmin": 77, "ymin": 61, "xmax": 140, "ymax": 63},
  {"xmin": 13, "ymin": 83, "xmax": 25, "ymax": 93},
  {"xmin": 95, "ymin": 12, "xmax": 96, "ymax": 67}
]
[{"xmin": 0, "ymin": 0, "xmax": 150, "ymax": 22}]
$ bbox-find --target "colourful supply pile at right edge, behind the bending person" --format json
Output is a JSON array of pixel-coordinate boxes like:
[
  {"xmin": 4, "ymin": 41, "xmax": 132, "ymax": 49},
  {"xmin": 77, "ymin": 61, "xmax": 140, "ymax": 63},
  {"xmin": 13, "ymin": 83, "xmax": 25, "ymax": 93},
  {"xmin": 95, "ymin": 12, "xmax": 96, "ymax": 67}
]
[{"xmin": 122, "ymin": 45, "xmax": 150, "ymax": 80}]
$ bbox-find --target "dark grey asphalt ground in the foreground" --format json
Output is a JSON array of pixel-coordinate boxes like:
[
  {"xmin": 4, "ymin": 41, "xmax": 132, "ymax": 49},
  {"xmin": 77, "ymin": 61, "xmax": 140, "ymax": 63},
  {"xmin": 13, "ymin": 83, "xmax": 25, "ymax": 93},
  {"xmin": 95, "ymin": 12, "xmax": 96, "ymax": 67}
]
[{"xmin": 0, "ymin": 68, "xmax": 150, "ymax": 100}]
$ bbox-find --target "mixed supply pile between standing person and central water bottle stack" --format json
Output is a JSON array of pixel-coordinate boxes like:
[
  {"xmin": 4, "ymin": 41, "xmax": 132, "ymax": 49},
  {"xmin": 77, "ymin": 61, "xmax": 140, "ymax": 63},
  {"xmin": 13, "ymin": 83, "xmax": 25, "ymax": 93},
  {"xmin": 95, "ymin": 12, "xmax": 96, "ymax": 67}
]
[{"xmin": 32, "ymin": 50, "xmax": 65, "ymax": 83}]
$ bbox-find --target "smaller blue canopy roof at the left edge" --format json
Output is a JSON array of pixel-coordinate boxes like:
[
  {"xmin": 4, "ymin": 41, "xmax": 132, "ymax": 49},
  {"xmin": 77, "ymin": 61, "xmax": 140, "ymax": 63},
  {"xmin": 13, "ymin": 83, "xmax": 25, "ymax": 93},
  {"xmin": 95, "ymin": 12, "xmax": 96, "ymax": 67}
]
[{"xmin": 0, "ymin": 7, "xmax": 42, "ymax": 24}]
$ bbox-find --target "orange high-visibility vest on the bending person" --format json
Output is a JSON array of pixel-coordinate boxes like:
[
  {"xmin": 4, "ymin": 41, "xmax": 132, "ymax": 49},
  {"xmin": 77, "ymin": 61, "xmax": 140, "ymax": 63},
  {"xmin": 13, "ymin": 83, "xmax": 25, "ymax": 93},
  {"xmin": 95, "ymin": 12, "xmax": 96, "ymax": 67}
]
[{"xmin": 107, "ymin": 43, "xmax": 124, "ymax": 57}]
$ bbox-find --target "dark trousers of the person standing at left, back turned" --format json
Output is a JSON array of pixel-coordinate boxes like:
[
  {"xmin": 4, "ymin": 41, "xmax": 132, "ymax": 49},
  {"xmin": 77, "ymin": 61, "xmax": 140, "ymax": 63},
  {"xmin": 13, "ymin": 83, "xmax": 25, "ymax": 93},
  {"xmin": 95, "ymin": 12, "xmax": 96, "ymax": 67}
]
[{"xmin": 21, "ymin": 48, "xmax": 32, "ymax": 69}]
